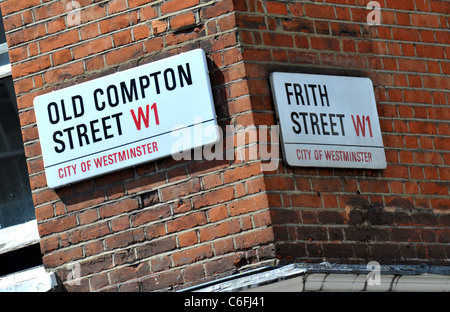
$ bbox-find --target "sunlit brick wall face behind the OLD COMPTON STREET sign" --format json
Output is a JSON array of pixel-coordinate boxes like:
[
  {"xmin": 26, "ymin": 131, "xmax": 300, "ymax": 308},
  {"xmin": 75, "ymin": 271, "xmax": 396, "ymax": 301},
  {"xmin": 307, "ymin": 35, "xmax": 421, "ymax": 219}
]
[{"xmin": 2, "ymin": 0, "xmax": 275, "ymax": 291}]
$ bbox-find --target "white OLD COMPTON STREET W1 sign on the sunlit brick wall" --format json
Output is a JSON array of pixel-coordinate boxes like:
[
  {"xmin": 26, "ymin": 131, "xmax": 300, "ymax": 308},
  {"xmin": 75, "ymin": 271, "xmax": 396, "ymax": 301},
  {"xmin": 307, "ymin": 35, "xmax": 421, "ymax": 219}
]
[{"xmin": 34, "ymin": 49, "xmax": 219, "ymax": 188}]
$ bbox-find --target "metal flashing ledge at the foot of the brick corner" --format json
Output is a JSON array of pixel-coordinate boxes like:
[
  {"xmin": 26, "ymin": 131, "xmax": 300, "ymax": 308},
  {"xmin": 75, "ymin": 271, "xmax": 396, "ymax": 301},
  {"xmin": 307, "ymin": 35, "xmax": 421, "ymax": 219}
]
[{"xmin": 182, "ymin": 262, "xmax": 450, "ymax": 292}]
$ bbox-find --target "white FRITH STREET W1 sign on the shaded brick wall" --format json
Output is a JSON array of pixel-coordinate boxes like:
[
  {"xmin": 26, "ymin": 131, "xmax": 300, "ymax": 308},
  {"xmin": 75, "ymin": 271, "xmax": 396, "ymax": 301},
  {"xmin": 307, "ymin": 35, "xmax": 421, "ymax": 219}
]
[{"xmin": 270, "ymin": 72, "xmax": 386, "ymax": 169}]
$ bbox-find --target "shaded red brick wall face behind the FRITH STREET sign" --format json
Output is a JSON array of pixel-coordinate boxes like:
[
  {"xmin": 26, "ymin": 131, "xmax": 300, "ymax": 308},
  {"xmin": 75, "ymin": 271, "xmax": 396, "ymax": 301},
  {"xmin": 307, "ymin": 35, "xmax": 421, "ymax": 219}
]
[{"xmin": 232, "ymin": 0, "xmax": 450, "ymax": 264}]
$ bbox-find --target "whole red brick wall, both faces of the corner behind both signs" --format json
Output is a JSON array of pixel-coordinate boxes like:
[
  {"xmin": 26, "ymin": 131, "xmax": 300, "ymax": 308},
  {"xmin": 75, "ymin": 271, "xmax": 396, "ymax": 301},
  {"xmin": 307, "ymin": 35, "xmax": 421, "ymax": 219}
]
[{"xmin": 1, "ymin": 0, "xmax": 450, "ymax": 291}]
